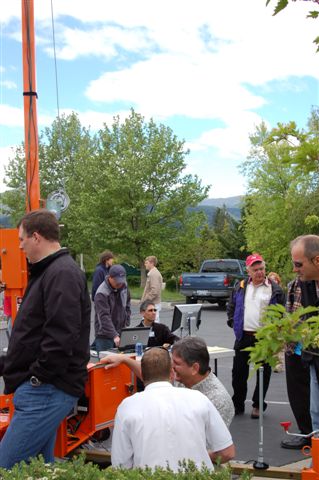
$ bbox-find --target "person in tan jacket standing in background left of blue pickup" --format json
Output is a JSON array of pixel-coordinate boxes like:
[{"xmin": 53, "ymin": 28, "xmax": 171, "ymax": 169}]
[{"xmin": 141, "ymin": 256, "xmax": 163, "ymax": 322}]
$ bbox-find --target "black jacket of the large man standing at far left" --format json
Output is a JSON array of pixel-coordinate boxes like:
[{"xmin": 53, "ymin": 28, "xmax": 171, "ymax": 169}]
[{"xmin": 0, "ymin": 249, "xmax": 91, "ymax": 397}]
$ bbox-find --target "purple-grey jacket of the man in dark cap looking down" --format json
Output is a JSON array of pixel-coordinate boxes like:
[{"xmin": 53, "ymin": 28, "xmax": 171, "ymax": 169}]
[{"xmin": 94, "ymin": 277, "xmax": 131, "ymax": 339}]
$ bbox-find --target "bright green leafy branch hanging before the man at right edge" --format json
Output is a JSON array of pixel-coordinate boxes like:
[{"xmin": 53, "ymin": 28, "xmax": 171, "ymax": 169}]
[{"xmin": 245, "ymin": 305, "xmax": 319, "ymax": 370}]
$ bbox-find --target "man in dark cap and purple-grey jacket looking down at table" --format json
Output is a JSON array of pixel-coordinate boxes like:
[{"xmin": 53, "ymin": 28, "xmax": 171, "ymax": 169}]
[{"xmin": 94, "ymin": 265, "xmax": 131, "ymax": 352}]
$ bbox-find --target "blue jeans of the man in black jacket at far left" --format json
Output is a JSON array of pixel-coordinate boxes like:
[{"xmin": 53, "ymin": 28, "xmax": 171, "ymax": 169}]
[{"xmin": 0, "ymin": 381, "xmax": 78, "ymax": 468}]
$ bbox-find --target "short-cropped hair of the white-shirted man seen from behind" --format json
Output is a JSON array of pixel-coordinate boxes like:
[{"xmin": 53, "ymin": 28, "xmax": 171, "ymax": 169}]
[{"xmin": 141, "ymin": 347, "xmax": 172, "ymax": 384}]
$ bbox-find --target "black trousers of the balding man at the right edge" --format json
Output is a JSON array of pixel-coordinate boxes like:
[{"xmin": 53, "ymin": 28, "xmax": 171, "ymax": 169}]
[{"xmin": 285, "ymin": 354, "xmax": 312, "ymax": 433}]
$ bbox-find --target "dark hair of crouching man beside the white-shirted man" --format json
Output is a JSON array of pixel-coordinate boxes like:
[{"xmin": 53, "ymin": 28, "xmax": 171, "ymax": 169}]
[{"xmin": 172, "ymin": 336, "xmax": 210, "ymax": 375}]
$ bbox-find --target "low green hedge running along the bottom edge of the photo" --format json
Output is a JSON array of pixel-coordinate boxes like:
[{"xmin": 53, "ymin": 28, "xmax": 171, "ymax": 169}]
[{"xmin": 0, "ymin": 455, "xmax": 250, "ymax": 480}]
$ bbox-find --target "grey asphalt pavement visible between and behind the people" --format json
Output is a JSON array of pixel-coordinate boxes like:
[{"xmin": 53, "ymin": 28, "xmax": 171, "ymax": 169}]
[{"xmin": 119, "ymin": 302, "xmax": 305, "ymax": 466}]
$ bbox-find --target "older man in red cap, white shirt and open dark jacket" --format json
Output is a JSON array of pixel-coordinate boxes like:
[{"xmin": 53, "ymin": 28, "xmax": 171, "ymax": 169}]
[{"xmin": 227, "ymin": 253, "xmax": 285, "ymax": 418}]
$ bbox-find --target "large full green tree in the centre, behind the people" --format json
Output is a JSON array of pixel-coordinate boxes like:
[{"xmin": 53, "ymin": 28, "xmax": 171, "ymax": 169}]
[{"xmin": 67, "ymin": 110, "xmax": 208, "ymax": 278}]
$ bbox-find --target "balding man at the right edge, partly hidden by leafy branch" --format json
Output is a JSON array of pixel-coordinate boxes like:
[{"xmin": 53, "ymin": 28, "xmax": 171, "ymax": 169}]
[{"xmin": 281, "ymin": 235, "xmax": 319, "ymax": 450}]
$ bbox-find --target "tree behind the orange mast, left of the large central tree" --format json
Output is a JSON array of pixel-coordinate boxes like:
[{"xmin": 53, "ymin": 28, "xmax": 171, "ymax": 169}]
[{"xmin": 3, "ymin": 113, "xmax": 96, "ymax": 248}]
